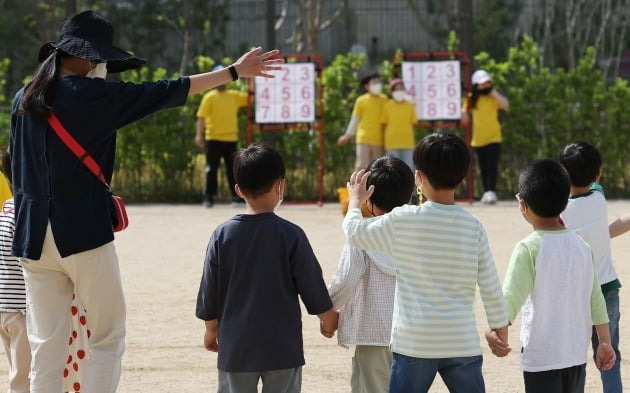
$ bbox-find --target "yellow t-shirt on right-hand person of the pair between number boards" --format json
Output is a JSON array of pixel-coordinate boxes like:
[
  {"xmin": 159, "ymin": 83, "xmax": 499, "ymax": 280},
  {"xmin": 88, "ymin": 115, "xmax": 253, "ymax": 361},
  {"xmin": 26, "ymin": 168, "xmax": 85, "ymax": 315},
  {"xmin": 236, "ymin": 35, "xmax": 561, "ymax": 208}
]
[{"xmin": 381, "ymin": 100, "xmax": 416, "ymax": 149}]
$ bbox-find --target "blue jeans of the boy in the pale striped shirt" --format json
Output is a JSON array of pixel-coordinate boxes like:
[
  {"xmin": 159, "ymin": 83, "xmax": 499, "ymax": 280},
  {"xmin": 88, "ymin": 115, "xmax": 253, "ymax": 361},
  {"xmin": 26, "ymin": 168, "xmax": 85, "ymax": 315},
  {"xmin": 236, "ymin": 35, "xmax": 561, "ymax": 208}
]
[{"xmin": 389, "ymin": 353, "xmax": 486, "ymax": 393}]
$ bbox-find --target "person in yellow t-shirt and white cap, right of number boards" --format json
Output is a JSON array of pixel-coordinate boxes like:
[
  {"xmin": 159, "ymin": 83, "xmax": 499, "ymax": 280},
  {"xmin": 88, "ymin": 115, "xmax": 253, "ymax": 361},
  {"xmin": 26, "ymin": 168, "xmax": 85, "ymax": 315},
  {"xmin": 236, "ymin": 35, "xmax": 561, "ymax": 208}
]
[{"xmin": 462, "ymin": 70, "xmax": 510, "ymax": 204}]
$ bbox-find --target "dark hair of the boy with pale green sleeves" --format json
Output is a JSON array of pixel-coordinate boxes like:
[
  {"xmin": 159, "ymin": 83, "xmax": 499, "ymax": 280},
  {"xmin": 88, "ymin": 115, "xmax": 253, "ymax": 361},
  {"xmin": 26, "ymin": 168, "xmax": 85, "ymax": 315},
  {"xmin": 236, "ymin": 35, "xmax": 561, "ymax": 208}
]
[{"xmin": 518, "ymin": 159, "xmax": 571, "ymax": 218}]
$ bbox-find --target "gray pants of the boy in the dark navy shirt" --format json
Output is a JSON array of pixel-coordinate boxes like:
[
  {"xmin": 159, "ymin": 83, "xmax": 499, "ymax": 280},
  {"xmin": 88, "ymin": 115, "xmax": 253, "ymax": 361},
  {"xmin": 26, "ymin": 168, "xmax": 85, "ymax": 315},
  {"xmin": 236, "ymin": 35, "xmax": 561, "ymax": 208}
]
[{"xmin": 218, "ymin": 367, "xmax": 302, "ymax": 393}]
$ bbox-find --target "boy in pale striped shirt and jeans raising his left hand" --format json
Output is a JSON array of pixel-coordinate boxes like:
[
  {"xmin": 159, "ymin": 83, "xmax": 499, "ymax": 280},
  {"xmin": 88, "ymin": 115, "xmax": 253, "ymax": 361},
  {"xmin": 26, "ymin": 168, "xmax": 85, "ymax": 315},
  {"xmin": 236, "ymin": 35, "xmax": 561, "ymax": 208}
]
[{"xmin": 343, "ymin": 133, "xmax": 507, "ymax": 393}]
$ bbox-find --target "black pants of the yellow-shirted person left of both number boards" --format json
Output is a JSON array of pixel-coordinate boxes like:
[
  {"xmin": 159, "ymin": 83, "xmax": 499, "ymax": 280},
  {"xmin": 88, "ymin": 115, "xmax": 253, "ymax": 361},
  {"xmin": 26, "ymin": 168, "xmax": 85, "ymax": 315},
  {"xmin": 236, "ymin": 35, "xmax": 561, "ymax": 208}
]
[{"xmin": 203, "ymin": 141, "xmax": 236, "ymax": 200}]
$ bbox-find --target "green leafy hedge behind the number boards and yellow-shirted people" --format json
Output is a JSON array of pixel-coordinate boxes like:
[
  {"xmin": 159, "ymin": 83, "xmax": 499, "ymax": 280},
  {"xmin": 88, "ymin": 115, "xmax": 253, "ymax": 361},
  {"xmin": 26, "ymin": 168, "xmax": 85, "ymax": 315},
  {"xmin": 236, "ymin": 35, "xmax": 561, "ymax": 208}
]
[{"xmin": 0, "ymin": 37, "xmax": 630, "ymax": 202}]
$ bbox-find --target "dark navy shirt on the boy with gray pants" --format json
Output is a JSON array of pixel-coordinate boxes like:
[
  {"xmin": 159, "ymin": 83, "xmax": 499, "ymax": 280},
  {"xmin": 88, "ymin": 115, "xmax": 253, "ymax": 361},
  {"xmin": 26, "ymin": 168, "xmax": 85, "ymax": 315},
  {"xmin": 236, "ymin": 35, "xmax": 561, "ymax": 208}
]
[{"xmin": 196, "ymin": 213, "xmax": 332, "ymax": 372}]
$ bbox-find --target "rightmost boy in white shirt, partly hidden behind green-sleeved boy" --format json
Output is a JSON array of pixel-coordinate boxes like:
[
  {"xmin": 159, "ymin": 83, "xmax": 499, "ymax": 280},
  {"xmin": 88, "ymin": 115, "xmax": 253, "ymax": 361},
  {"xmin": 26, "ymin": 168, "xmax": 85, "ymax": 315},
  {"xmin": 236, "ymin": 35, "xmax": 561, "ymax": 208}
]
[{"xmin": 560, "ymin": 142, "xmax": 623, "ymax": 393}]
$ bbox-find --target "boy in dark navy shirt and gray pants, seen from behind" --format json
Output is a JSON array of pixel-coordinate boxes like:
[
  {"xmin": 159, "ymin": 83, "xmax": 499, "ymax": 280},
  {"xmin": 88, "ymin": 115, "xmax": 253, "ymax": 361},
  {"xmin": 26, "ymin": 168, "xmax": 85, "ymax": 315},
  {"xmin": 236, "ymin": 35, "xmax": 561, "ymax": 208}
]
[{"xmin": 196, "ymin": 145, "xmax": 338, "ymax": 393}]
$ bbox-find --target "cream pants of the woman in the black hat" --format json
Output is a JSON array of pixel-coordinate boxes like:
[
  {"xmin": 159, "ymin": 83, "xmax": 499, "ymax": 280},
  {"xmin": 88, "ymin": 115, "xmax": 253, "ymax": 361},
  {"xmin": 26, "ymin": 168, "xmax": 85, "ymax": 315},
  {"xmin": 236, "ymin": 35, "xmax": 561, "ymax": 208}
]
[{"xmin": 21, "ymin": 224, "xmax": 125, "ymax": 393}]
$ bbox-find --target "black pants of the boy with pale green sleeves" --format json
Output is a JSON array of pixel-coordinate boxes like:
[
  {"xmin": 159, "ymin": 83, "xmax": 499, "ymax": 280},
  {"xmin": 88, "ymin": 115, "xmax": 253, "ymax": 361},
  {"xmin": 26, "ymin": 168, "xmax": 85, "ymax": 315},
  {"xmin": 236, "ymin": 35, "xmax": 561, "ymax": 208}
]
[{"xmin": 523, "ymin": 364, "xmax": 586, "ymax": 393}]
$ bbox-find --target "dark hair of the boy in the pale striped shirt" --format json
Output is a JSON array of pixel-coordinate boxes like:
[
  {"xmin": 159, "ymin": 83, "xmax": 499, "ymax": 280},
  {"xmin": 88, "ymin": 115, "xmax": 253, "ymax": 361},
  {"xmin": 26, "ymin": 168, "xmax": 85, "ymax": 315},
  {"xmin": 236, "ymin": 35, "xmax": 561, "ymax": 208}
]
[{"xmin": 413, "ymin": 132, "xmax": 470, "ymax": 190}]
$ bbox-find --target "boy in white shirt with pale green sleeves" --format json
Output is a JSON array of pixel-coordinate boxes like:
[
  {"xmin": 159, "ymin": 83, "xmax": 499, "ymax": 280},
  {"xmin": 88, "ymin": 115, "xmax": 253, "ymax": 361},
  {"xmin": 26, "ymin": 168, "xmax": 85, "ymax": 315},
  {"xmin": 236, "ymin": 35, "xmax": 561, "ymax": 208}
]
[{"xmin": 486, "ymin": 160, "xmax": 615, "ymax": 393}]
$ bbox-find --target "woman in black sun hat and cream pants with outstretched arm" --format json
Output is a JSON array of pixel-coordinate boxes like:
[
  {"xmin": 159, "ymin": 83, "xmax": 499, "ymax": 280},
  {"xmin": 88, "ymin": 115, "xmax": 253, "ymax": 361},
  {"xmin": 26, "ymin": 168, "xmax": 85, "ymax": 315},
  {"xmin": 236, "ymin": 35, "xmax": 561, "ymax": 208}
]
[{"xmin": 10, "ymin": 11, "xmax": 282, "ymax": 393}]
